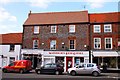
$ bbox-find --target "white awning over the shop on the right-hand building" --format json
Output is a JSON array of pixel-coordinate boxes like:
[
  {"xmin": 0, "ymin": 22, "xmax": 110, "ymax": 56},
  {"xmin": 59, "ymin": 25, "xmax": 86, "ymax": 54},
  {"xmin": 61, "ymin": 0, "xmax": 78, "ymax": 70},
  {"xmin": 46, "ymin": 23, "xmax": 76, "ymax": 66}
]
[{"xmin": 93, "ymin": 51, "xmax": 119, "ymax": 57}]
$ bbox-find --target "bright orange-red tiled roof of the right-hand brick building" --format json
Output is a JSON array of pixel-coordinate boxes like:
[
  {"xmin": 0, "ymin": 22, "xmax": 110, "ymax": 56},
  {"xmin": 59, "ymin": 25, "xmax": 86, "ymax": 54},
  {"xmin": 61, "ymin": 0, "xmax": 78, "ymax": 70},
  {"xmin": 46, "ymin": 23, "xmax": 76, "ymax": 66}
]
[{"xmin": 89, "ymin": 12, "xmax": 120, "ymax": 23}]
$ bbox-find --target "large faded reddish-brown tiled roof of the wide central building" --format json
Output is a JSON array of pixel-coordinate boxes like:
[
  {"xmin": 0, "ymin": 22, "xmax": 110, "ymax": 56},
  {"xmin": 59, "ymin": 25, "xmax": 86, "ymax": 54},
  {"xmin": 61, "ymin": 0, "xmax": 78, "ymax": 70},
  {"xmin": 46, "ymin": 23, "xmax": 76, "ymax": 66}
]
[{"xmin": 23, "ymin": 11, "xmax": 88, "ymax": 25}]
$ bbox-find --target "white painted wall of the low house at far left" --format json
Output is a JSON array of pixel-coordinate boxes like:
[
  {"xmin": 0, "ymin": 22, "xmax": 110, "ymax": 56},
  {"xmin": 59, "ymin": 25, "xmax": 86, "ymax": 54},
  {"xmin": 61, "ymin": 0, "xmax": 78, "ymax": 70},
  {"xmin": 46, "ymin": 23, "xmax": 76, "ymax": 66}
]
[{"xmin": 0, "ymin": 45, "xmax": 21, "ymax": 67}]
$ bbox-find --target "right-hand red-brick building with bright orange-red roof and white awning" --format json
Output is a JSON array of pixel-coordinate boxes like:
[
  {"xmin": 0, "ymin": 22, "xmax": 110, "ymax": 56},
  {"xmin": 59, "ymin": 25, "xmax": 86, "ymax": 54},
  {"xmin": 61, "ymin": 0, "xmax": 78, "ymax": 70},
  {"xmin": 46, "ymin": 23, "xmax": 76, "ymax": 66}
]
[{"xmin": 89, "ymin": 12, "xmax": 120, "ymax": 69}]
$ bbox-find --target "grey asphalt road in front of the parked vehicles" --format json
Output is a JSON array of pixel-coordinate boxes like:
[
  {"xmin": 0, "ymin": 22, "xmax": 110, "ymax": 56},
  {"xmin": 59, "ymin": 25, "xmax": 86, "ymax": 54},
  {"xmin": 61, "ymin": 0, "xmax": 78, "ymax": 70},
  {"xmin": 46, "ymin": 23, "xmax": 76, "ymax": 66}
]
[{"xmin": 2, "ymin": 71, "xmax": 120, "ymax": 80}]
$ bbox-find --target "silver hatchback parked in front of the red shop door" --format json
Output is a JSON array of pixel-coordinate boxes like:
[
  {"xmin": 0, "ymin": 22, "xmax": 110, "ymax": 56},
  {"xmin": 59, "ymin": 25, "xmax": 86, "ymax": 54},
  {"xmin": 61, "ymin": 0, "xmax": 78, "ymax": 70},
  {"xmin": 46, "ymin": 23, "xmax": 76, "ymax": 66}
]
[{"xmin": 68, "ymin": 63, "xmax": 101, "ymax": 76}]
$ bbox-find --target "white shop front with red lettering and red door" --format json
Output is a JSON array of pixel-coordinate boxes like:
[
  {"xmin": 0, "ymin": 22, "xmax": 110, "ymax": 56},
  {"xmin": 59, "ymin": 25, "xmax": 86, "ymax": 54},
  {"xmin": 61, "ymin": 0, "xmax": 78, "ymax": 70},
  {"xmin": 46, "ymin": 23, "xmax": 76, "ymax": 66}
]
[{"xmin": 42, "ymin": 51, "xmax": 89, "ymax": 72}]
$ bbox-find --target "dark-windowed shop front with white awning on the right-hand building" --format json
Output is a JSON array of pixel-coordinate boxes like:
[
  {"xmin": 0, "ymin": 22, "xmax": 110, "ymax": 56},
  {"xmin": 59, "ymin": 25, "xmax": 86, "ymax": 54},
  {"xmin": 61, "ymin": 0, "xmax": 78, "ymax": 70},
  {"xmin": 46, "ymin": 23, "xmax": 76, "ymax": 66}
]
[{"xmin": 93, "ymin": 51, "xmax": 120, "ymax": 69}]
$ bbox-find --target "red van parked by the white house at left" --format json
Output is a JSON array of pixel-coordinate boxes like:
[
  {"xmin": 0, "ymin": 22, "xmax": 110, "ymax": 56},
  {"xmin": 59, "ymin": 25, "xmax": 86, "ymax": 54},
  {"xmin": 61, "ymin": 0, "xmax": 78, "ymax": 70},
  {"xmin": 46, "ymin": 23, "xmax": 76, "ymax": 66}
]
[{"xmin": 2, "ymin": 60, "xmax": 32, "ymax": 73}]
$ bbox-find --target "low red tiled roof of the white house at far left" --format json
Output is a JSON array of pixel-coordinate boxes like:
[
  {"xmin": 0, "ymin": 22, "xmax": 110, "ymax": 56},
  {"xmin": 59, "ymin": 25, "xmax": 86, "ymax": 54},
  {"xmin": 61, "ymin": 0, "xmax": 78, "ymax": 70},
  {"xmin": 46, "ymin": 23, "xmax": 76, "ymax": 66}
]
[{"xmin": 0, "ymin": 33, "xmax": 22, "ymax": 44}]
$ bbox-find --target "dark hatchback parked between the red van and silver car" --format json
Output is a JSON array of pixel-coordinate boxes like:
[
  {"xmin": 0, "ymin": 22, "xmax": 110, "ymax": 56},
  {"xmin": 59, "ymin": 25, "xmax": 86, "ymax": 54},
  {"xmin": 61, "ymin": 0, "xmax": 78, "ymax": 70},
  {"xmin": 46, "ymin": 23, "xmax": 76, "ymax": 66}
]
[{"xmin": 35, "ymin": 63, "xmax": 64, "ymax": 75}]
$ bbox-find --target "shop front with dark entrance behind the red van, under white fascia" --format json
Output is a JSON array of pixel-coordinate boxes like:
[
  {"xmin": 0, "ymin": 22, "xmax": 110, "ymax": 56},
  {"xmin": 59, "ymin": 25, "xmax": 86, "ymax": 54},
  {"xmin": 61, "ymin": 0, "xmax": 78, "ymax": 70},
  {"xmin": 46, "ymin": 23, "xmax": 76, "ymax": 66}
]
[{"xmin": 21, "ymin": 49, "xmax": 43, "ymax": 69}]
